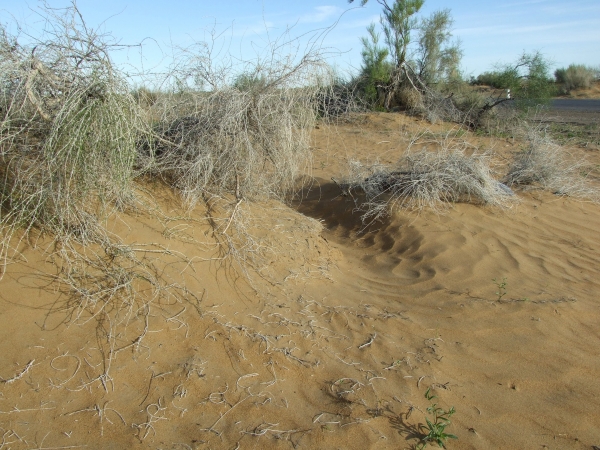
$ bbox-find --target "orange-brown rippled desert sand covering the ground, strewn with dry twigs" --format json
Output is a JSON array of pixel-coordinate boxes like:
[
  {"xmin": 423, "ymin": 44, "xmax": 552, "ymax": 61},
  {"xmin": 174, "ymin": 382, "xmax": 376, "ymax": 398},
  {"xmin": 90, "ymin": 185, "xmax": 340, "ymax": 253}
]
[{"xmin": 0, "ymin": 110, "xmax": 600, "ymax": 450}]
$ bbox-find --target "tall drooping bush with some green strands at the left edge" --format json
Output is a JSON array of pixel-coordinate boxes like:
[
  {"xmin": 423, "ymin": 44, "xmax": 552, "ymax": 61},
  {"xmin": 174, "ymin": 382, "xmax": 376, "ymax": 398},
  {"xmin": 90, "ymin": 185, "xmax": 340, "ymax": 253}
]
[{"xmin": 0, "ymin": 6, "xmax": 145, "ymax": 270}]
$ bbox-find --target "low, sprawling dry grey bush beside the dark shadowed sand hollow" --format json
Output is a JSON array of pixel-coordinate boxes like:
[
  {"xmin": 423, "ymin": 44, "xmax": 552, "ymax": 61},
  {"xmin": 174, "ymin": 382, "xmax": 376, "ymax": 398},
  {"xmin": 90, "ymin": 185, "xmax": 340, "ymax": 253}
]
[{"xmin": 345, "ymin": 136, "xmax": 514, "ymax": 222}]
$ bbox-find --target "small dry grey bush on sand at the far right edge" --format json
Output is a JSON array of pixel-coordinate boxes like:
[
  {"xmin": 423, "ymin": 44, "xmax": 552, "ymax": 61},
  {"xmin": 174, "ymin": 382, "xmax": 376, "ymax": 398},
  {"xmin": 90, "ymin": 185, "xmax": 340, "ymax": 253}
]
[{"xmin": 504, "ymin": 127, "xmax": 600, "ymax": 201}]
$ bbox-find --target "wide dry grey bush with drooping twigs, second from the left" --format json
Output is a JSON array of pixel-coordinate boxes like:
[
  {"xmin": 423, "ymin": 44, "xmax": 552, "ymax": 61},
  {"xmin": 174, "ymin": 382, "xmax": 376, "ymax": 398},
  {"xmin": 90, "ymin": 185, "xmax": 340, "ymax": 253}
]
[{"xmin": 146, "ymin": 87, "xmax": 315, "ymax": 206}]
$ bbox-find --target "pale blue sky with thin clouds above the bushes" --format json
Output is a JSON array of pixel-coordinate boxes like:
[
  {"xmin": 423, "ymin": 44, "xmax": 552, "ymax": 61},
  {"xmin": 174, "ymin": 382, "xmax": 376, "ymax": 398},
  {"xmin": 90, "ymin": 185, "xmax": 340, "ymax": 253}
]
[{"xmin": 0, "ymin": 0, "xmax": 600, "ymax": 80}]
